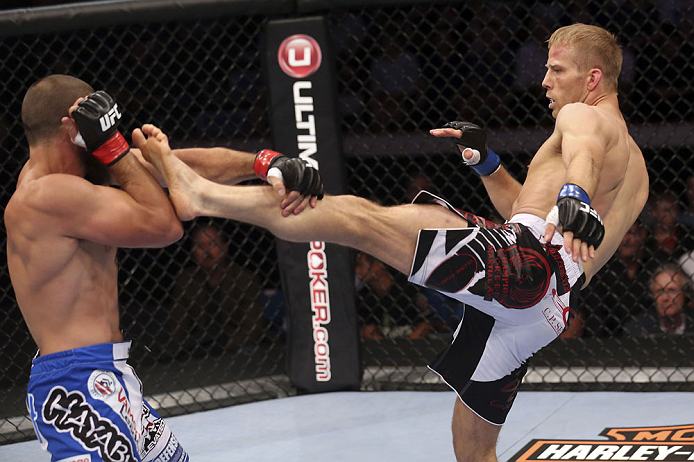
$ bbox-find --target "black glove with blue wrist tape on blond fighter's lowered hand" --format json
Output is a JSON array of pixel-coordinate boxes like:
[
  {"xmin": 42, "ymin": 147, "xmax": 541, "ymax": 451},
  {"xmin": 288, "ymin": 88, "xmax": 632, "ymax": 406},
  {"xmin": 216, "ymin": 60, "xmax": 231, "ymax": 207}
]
[{"xmin": 545, "ymin": 183, "xmax": 605, "ymax": 249}]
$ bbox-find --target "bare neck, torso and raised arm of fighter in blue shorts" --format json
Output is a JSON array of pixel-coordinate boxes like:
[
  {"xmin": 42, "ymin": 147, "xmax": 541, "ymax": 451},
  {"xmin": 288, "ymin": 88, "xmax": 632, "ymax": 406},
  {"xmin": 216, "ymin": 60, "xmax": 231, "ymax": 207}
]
[{"xmin": 5, "ymin": 125, "xmax": 183, "ymax": 355}]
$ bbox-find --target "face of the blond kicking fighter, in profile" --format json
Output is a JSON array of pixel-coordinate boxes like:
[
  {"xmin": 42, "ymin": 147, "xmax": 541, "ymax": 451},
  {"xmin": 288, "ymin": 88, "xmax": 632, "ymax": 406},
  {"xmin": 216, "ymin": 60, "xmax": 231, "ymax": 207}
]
[{"xmin": 542, "ymin": 45, "xmax": 587, "ymax": 119}]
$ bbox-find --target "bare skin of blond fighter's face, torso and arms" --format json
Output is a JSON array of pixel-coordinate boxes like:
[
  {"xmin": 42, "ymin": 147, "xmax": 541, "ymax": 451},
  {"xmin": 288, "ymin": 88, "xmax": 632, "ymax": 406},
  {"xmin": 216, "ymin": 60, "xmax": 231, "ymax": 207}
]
[{"xmin": 431, "ymin": 45, "xmax": 648, "ymax": 285}]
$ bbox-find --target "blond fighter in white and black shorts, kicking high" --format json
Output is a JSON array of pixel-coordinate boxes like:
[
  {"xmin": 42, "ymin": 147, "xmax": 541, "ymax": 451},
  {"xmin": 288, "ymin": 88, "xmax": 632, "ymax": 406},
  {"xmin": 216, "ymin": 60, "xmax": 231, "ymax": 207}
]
[{"xmin": 137, "ymin": 24, "xmax": 648, "ymax": 462}]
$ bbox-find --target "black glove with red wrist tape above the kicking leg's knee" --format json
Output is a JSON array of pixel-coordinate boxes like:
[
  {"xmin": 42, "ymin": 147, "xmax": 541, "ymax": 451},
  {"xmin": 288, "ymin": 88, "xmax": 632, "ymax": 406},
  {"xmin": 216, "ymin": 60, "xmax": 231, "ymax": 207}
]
[{"xmin": 253, "ymin": 149, "xmax": 324, "ymax": 199}]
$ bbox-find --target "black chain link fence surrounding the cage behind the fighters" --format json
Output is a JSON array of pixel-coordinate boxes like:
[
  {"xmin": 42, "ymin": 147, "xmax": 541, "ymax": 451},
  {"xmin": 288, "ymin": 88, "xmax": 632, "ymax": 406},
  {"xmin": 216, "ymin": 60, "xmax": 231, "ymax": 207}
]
[{"xmin": 0, "ymin": 0, "xmax": 694, "ymax": 443}]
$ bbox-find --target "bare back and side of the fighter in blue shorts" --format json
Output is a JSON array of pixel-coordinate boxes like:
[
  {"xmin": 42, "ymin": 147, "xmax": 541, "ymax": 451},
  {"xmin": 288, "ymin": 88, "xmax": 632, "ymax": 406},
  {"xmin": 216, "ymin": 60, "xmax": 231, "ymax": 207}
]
[{"xmin": 5, "ymin": 167, "xmax": 120, "ymax": 354}]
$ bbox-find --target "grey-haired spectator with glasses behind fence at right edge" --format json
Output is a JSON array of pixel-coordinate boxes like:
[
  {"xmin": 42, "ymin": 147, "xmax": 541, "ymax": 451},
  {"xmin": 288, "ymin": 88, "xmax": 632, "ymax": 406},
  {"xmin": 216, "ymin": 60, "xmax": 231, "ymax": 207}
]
[{"xmin": 624, "ymin": 262, "xmax": 694, "ymax": 337}]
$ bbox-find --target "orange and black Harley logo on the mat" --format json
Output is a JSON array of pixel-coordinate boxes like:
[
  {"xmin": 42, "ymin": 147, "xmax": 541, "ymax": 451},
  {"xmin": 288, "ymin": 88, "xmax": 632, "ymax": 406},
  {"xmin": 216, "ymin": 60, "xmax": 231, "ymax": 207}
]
[{"xmin": 509, "ymin": 424, "xmax": 694, "ymax": 462}]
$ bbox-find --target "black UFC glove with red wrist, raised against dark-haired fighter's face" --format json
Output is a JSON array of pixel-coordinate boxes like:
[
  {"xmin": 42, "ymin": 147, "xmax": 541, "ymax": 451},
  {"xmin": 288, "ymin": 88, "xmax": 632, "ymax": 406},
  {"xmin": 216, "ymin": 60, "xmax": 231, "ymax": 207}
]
[{"xmin": 72, "ymin": 91, "xmax": 130, "ymax": 167}]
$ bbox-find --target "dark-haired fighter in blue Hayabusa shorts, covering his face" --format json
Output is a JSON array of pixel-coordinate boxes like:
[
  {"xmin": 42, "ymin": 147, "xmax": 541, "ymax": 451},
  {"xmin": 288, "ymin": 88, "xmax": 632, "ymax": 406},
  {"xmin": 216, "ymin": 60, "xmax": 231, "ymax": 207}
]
[{"xmin": 5, "ymin": 75, "xmax": 322, "ymax": 462}]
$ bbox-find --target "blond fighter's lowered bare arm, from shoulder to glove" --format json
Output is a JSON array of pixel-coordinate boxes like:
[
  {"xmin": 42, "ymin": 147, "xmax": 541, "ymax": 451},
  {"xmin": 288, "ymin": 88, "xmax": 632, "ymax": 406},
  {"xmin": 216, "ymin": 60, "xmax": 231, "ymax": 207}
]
[{"xmin": 556, "ymin": 104, "xmax": 609, "ymax": 198}]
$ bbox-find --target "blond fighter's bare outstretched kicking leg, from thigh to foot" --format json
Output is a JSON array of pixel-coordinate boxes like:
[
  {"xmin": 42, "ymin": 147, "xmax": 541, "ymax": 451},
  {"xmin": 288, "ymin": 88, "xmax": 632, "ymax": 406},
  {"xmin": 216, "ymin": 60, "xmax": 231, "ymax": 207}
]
[{"xmin": 138, "ymin": 122, "xmax": 467, "ymax": 274}]
